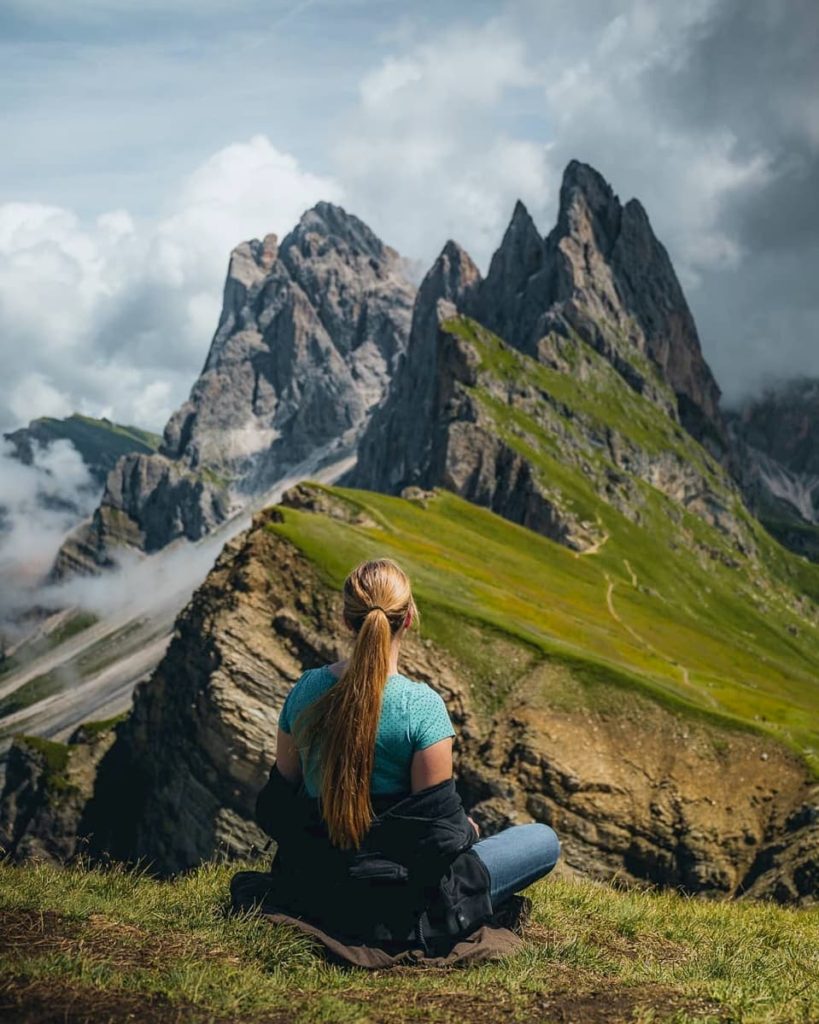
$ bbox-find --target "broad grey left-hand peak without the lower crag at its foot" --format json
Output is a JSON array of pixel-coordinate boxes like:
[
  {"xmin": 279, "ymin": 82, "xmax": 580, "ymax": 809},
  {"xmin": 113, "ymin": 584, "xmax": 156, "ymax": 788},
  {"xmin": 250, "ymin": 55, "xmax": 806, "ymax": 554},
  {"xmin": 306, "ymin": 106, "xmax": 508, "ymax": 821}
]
[{"xmin": 162, "ymin": 203, "xmax": 415, "ymax": 492}]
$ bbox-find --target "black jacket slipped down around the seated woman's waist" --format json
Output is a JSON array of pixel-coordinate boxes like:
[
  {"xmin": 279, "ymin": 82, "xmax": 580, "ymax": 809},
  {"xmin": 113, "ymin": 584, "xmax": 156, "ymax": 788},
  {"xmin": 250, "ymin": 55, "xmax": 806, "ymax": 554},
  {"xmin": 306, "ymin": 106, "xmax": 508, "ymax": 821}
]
[{"xmin": 256, "ymin": 765, "xmax": 492, "ymax": 952}]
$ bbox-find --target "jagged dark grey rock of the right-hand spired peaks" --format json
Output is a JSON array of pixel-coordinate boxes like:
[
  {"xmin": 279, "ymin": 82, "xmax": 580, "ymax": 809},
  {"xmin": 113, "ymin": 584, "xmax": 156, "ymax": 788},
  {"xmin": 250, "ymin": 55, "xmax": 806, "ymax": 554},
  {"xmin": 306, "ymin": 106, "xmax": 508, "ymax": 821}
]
[{"xmin": 344, "ymin": 162, "xmax": 737, "ymax": 551}]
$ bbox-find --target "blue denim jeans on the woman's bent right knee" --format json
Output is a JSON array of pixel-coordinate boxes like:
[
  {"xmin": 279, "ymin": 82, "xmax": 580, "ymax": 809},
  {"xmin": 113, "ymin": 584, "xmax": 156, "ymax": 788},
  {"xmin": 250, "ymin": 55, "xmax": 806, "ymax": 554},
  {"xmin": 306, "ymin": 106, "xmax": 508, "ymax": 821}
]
[{"xmin": 472, "ymin": 821, "xmax": 560, "ymax": 907}]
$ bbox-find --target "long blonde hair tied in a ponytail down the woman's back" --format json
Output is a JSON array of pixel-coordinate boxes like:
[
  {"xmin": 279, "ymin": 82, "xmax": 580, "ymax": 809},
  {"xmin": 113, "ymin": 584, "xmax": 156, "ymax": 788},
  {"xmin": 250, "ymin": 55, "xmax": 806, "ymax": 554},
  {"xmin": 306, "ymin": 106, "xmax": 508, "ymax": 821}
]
[{"xmin": 294, "ymin": 558, "xmax": 418, "ymax": 849}]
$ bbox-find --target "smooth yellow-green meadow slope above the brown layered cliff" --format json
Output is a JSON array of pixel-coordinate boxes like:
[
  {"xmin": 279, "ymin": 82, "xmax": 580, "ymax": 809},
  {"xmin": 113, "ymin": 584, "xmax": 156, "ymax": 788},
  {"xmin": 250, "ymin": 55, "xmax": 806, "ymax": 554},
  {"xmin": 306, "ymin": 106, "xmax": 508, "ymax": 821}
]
[{"xmin": 269, "ymin": 487, "xmax": 819, "ymax": 770}]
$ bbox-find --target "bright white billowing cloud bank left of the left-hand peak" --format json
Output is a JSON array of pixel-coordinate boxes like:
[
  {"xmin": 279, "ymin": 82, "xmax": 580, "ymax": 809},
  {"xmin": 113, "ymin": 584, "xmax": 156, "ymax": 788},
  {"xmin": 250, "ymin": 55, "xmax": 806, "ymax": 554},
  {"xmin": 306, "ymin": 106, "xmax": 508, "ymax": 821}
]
[{"xmin": 0, "ymin": 135, "xmax": 341, "ymax": 430}]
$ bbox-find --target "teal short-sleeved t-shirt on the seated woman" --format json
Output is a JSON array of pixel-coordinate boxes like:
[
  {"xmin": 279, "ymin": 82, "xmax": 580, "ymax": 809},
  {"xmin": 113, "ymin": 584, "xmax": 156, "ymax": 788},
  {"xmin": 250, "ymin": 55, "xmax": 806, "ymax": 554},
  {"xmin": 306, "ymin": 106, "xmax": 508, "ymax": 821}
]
[{"xmin": 278, "ymin": 666, "xmax": 455, "ymax": 797}]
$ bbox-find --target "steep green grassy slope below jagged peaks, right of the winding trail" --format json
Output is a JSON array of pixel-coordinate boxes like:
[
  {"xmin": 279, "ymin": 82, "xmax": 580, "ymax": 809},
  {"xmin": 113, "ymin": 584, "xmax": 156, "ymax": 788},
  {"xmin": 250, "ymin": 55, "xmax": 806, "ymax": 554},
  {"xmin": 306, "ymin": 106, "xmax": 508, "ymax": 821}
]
[{"xmin": 438, "ymin": 317, "xmax": 819, "ymax": 753}]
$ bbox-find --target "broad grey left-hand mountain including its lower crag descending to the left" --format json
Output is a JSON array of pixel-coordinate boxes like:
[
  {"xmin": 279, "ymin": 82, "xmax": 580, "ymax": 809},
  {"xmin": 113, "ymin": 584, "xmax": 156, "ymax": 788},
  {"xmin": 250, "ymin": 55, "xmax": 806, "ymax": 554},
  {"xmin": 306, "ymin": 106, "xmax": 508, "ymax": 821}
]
[{"xmin": 55, "ymin": 203, "xmax": 415, "ymax": 575}]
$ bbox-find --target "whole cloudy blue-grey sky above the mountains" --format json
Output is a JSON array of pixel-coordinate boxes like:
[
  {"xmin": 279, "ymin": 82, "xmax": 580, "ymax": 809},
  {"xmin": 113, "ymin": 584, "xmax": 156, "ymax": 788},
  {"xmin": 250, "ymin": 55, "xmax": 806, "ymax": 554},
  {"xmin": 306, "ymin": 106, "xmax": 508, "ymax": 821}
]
[{"xmin": 0, "ymin": 0, "xmax": 819, "ymax": 431}]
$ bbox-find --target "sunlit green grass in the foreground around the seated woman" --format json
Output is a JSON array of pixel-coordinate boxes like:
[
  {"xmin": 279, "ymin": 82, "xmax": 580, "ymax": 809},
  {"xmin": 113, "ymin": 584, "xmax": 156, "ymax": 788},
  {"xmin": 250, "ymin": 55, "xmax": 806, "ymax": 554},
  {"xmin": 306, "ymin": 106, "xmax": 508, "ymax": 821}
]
[{"xmin": 0, "ymin": 863, "xmax": 819, "ymax": 1024}]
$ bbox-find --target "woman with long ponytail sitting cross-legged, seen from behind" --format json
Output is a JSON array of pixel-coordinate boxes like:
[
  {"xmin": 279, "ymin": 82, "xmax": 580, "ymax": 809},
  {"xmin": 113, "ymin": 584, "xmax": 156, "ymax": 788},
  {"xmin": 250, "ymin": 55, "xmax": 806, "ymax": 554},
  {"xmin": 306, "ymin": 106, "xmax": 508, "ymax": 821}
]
[{"xmin": 246, "ymin": 558, "xmax": 560, "ymax": 946}]
